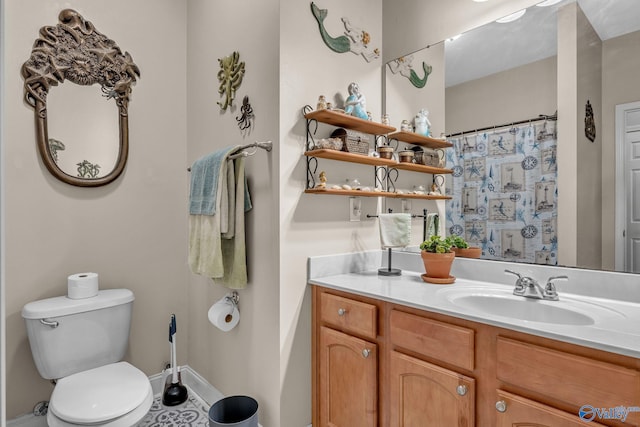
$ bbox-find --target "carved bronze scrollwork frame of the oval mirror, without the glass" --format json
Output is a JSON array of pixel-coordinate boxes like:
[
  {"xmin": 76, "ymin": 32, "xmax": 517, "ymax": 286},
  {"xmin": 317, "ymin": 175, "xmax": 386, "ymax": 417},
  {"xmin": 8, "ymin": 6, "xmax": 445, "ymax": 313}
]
[{"xmin": 21, "ymin": 9, "xmax": 140, "ymax": 187}]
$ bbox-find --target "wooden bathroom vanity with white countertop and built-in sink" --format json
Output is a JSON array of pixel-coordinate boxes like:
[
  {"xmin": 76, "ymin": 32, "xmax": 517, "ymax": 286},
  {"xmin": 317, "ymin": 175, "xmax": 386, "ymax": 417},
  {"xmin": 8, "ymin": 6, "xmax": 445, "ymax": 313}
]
[{"xmin": 309, "ymin": 254, "xmax": 640, "ymax": 427}]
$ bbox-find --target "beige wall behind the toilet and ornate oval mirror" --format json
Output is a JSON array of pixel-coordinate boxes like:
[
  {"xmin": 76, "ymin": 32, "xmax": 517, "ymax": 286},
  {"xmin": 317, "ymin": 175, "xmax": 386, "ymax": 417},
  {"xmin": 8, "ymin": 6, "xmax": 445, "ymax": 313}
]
[{"xmin": 2, "ymin": 0, "xmax": 188, "ymax": 418}]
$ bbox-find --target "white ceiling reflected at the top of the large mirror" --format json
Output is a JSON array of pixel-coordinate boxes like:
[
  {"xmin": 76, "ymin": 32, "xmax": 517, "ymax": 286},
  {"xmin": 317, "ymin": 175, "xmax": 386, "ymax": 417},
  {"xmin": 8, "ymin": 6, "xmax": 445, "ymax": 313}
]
[{"xmin": 445, "ymin": 0, "xmax": 640, "ymax": 87}]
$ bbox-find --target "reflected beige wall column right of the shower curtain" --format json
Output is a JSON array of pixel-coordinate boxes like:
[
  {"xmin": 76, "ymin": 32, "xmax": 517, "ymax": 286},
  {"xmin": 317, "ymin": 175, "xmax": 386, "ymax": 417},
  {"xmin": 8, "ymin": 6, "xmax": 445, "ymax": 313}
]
[{"xmin": 558, "ymin": 3, "xmax": 602, "ymax": 268}]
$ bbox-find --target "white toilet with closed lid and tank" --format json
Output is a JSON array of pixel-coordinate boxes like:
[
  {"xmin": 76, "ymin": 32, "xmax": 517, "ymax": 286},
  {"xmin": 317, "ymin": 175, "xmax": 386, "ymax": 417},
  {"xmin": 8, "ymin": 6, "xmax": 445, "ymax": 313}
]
[{"xmin": 22, "ymin": 289, "xmax": 153, "ymax": 427}]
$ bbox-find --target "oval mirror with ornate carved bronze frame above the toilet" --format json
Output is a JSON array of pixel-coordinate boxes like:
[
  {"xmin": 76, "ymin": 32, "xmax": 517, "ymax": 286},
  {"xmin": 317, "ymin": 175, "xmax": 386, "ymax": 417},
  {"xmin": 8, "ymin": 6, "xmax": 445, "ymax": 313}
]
[{"xmin": 22, "ymin": 9, "xmax": 140, "ymax": 187}]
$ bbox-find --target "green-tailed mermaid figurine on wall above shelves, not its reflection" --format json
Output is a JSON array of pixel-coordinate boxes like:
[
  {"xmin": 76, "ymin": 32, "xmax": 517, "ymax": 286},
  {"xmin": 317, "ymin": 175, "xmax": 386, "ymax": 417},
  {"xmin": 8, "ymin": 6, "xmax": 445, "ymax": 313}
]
[{"xmin": 311, "ymin": 2, "xmax": 380, "ymax": 62}]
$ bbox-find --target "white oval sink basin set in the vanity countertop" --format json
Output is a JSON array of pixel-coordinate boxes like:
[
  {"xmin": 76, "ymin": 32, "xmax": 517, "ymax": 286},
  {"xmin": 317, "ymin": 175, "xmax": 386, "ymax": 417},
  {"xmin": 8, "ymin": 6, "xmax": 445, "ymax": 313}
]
[{"xmin": 439, "ymin": 288, "xmax": 621, "ymax": 326}]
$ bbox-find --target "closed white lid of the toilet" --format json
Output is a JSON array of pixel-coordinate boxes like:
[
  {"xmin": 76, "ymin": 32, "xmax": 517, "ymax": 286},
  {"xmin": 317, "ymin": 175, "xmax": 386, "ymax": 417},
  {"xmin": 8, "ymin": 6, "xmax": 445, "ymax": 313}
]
[{"xmin": 49, "ymin": 362, "xmax": 150, "ymax": 424}]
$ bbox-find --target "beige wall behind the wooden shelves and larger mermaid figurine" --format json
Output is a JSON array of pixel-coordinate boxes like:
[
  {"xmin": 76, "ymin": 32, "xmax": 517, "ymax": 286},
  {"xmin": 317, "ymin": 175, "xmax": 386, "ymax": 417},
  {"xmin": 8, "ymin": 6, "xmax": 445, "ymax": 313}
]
[{"xmin": 278, "ymin": 0, "xmax": 382, "ymax": 427}]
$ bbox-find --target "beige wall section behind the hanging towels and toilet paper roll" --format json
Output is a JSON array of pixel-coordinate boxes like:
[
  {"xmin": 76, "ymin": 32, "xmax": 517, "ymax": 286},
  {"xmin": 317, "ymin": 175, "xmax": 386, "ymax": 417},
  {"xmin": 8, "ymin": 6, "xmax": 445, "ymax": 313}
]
[{"xmin": 182, "ymin": 0, "xmax": 282, "ymax": 426}]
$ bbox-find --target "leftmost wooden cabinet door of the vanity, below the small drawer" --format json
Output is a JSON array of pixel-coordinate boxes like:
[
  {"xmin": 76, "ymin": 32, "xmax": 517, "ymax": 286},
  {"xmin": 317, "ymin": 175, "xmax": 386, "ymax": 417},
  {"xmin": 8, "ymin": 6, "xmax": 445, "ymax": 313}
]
[{"xmin": 318, "ymin": 326, "xmax": 378, "ymax": 427}]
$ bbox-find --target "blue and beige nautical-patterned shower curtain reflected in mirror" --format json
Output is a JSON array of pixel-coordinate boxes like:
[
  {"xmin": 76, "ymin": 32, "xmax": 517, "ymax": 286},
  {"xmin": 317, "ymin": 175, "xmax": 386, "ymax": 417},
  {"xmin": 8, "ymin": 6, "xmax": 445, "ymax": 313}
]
[{"xmin": 446, "ymin": 120, "xmax": 558, "ymax": 265}]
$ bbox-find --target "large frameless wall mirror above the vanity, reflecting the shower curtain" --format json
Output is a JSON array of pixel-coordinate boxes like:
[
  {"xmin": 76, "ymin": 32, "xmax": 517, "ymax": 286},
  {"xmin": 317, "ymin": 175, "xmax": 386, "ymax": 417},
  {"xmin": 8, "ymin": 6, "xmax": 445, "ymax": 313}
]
[{"xmin": 385, "ymin": 0, "xmax": 640, "ymax": 273}]
